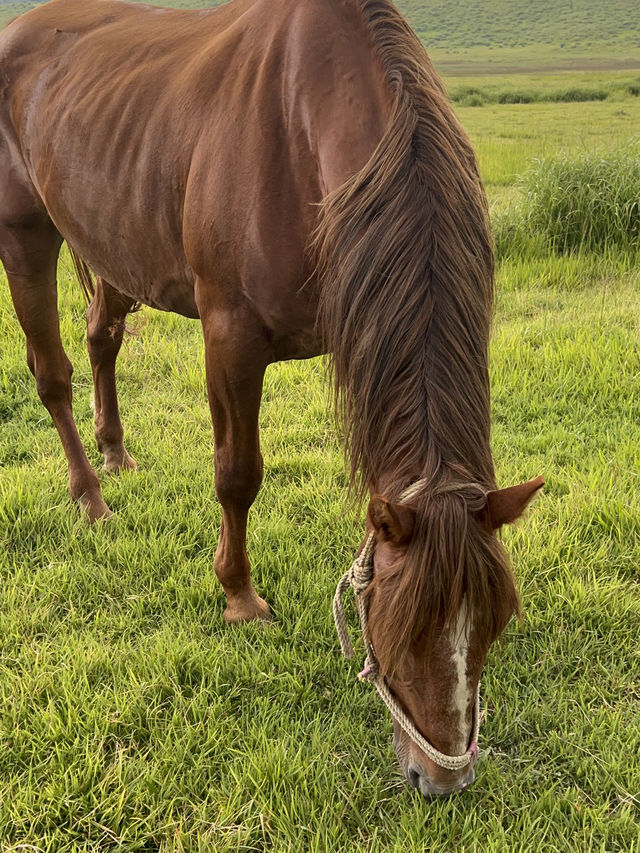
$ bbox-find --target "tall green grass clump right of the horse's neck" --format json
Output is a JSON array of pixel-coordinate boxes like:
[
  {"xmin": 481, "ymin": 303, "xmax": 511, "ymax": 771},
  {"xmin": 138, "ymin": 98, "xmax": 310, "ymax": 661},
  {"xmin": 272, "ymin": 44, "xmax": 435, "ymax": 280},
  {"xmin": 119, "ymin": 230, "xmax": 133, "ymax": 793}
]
[{"xmin": 494, "ymin": 140, "xmax": 640, "ymax": 257}]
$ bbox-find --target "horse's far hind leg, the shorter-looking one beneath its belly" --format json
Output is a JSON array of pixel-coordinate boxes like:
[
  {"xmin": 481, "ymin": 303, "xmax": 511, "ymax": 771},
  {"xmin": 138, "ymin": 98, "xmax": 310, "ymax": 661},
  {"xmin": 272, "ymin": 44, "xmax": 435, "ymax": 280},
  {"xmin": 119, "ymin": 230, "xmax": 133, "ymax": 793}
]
[{"xmin": 87, "ymin": 278, "xmax": 136, "ymax": 471}]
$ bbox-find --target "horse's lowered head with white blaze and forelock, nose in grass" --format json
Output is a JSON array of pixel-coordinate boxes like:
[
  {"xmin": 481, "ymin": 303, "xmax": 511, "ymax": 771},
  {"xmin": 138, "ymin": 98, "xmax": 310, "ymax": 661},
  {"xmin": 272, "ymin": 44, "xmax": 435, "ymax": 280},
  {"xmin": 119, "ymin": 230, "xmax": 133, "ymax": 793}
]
[{"xmin": 367, "ymin": 478, "xmax": 544, "ymax": 796}]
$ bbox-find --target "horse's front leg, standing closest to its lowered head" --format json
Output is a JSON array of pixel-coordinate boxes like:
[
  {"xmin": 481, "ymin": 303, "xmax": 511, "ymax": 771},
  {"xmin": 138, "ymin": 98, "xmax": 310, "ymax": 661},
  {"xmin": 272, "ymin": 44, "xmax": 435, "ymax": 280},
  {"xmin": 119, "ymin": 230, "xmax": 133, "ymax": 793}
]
[{"xmin": 201, "ymin": 310, "xmax": 269, "ymax": 622}]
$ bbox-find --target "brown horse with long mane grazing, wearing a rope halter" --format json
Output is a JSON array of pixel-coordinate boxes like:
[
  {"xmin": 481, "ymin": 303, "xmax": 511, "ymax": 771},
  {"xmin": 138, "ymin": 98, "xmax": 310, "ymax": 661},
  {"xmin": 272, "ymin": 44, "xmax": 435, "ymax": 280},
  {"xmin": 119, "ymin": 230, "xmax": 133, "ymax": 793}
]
[{"xmin": 0, "ymin": 0, "xmax": 542, "ymax": 795}]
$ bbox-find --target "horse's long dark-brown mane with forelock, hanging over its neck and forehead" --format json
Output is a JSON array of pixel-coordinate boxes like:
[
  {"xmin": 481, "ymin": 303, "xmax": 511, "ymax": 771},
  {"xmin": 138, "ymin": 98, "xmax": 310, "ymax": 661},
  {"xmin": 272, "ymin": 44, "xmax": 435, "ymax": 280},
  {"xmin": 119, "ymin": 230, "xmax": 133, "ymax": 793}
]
[{"xmin": 314, "ymin": 0, "xmax": 517, "ymax": 668}]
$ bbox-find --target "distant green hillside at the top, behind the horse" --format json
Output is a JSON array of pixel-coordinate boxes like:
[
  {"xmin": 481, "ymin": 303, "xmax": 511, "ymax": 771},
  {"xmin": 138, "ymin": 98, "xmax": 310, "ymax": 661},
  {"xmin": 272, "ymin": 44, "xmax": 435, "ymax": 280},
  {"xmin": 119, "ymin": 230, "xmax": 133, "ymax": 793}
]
[{"xmin": 0, "ymin": 0, "xmax": 640, "ymax": 72}]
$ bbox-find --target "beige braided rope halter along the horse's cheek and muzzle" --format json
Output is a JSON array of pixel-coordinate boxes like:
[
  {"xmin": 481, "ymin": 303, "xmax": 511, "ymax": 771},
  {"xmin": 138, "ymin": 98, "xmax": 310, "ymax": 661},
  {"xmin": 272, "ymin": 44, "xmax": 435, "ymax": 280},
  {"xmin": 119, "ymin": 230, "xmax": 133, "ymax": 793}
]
[{"xmin": 333, "ymin": 532, "xmax": 480, "ymax": 770}]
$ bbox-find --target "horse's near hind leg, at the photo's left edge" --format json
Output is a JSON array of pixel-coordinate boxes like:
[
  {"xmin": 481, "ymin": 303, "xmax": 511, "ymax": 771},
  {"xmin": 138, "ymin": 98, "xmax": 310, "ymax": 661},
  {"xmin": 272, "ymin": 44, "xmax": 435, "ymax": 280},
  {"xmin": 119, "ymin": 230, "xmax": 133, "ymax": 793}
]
[{"xmin": 0, "ymin": 220, "xmax": 111, "ymax": 521}]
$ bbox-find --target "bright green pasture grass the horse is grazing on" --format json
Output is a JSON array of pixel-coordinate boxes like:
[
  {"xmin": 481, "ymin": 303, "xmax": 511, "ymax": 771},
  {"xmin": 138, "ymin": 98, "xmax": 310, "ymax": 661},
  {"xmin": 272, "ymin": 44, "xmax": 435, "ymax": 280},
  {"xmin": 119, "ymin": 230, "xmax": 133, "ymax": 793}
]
[{"xmin": 0, "ymin": 36, "xmax": 640, "ymax": 853}]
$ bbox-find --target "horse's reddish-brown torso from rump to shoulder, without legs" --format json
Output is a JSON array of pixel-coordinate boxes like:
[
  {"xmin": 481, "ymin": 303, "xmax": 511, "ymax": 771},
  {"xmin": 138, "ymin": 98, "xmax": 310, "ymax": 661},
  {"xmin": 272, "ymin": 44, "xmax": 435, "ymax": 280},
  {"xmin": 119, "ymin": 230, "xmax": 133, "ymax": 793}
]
[{"xmin": 0, "ymin": 0, "xmax": 386, "ymax": 344}]
